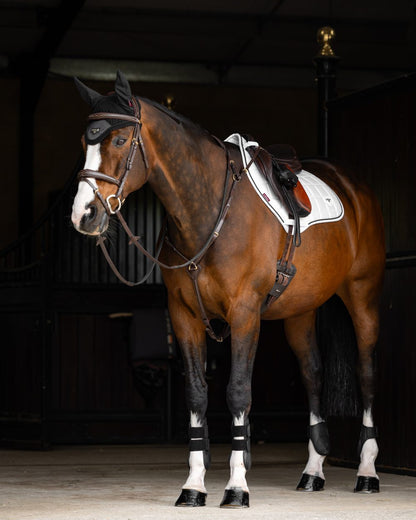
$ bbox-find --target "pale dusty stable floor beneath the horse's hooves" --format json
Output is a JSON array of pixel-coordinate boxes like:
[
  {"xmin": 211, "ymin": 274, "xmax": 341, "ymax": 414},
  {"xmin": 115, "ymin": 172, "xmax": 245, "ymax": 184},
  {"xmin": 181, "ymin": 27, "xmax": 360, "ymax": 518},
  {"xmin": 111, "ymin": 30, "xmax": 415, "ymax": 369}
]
[{"xmin": 0, "ymin": 444, "xmax": 416, "ymax": 520}]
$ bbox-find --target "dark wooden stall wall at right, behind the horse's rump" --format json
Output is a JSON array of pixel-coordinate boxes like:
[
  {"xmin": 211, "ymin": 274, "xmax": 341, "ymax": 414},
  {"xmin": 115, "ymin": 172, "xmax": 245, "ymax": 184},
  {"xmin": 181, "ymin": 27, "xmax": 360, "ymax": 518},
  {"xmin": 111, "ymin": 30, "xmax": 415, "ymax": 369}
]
[{"xmin": 328, "ymin": 75, "xmax": 416, "ymax": 473}]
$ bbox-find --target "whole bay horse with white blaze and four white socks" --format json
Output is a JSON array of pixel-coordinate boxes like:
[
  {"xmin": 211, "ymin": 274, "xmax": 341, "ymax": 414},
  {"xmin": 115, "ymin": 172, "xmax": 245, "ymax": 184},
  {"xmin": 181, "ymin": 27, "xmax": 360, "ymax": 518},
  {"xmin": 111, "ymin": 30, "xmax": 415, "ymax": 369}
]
[{"xmin": 72, "ymin": 72, "xmax": 385, "ymax": 507}]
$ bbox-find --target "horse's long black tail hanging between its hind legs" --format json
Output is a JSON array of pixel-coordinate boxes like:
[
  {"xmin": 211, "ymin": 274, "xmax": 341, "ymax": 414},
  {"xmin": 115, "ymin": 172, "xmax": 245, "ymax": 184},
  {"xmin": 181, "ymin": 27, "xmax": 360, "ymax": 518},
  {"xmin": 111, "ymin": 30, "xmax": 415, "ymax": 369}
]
[{"xmin": 316, "ymin": 296, "xmax": 361, "ymax": 417}]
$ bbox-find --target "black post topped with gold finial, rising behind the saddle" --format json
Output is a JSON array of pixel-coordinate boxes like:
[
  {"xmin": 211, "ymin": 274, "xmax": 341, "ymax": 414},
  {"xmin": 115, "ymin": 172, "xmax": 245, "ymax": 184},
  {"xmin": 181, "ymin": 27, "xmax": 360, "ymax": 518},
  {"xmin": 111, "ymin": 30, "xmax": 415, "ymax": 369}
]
[{"xmin": 313, "ymin": 27, "xmax": 339, "ymax": 157}]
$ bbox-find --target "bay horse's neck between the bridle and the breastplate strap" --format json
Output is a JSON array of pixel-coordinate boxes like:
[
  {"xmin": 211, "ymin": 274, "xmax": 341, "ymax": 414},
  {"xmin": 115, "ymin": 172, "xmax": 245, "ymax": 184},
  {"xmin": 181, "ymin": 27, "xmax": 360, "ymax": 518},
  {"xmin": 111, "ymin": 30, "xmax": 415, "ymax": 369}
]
[{"xmin": 144, "ymin": 107, "xmax": 226, "ymax": 255}]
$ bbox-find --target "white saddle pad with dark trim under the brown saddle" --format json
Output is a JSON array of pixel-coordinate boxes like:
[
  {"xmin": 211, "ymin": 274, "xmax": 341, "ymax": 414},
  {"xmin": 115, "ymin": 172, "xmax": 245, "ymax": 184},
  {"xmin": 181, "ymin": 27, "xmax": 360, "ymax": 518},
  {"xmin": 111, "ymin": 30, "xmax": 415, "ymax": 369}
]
[{"xmin": 225, "ymin": 134, "xmax": 344, "ymax": 232}]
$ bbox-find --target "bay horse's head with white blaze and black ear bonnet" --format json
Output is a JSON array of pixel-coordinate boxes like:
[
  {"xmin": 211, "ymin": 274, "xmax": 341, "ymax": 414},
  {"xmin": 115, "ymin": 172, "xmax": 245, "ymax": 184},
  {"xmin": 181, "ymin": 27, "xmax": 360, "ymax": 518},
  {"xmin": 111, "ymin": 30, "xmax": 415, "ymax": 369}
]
[{"xmin": 71, "ymin": 71, "xmax": 148, "ymax": 235}]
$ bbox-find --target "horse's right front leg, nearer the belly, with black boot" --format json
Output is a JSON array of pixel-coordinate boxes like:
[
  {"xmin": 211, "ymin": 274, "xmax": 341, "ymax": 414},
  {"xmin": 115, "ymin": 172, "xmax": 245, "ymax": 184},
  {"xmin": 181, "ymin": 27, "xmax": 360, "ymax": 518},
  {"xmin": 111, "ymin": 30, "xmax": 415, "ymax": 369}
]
[{"xmin": 221, "ymin": 312, "xmax": 260, "ymax": 508}]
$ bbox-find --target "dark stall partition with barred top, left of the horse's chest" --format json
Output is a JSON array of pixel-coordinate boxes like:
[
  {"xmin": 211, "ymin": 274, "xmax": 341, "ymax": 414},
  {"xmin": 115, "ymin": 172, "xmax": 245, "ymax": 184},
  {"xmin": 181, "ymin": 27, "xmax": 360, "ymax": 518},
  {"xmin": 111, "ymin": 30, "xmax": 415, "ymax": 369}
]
[{"xmin": 0, "ymin": 180, "xmax": 169, "ymax": 448}]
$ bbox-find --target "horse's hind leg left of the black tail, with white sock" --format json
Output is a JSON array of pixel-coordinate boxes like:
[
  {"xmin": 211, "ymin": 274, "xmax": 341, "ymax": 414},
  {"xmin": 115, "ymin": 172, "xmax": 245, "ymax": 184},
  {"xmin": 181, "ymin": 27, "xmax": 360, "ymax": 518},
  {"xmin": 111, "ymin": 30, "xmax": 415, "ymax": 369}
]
[{"xmin": 285, "ymin": 311, "xmax": 329, "ymax": 491}]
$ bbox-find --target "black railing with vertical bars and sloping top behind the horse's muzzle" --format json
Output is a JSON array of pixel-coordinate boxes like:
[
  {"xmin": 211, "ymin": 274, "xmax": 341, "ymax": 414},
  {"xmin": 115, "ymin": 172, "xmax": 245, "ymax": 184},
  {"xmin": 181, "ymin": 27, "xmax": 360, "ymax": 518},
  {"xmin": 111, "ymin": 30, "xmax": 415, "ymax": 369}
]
[{"xmin": 0, "ymin": 159, "xmax": 164, "ymax": 286}]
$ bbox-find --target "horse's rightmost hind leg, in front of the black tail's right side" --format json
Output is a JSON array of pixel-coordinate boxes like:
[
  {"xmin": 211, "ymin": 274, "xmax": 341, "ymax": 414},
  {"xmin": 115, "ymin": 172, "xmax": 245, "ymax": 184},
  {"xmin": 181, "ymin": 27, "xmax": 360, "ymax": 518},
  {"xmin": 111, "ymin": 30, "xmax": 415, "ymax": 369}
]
[{"xmin": 340, "ymin": 279, "xmax": 379, "ymax": 493}]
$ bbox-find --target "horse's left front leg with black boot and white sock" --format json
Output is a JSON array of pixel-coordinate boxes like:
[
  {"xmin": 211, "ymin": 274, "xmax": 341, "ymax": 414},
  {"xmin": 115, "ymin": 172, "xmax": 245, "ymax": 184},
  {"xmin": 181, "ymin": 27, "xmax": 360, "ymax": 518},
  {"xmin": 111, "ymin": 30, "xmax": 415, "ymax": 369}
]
[{"xmin": 171, "ymin": 313, "xmax": 210, "ymax": 507}]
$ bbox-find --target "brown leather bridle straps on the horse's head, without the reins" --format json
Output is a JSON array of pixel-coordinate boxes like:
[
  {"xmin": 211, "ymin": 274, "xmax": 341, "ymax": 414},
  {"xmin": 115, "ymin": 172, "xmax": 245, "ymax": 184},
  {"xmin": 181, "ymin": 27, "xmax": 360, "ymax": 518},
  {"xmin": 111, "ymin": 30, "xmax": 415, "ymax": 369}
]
[{"xmin": 78, "ymin": 97, "xmax": 149, "ymax": 216}]
